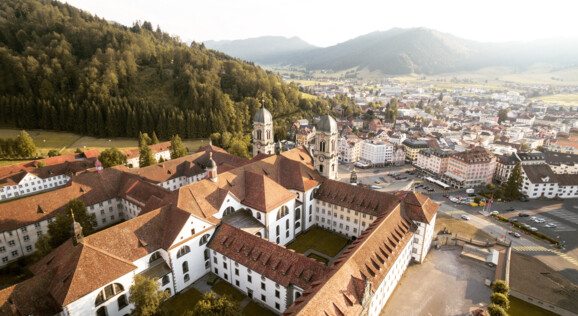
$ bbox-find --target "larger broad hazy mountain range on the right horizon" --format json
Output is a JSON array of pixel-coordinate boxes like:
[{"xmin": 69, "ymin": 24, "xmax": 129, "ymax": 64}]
[{"xmin": 205, "ymin": 28, "xmax": 578, "ymax": 75}]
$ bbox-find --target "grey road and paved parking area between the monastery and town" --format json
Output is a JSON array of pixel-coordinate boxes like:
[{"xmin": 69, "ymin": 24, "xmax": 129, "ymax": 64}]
[{"xmin": 339, "ymin": 164, "xmax": 578, "ymax": 283}]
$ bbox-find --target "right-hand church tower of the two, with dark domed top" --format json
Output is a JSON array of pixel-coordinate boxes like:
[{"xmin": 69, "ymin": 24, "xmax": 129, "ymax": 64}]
[{"xmin": 312, "ymin": 114, "xmax": 338, "ymax": 180}]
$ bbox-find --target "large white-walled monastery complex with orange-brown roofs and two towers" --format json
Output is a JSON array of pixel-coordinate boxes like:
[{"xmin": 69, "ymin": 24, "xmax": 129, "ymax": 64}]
[{"xmin": 0, "ymin": 109, "xmax": 439, "ymax": 316}]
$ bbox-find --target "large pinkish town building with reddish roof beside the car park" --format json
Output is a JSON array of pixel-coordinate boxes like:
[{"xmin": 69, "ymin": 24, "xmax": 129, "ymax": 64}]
[{"xmin": 442, "ymin": 147, "xmax": 496, "ymax": 188}]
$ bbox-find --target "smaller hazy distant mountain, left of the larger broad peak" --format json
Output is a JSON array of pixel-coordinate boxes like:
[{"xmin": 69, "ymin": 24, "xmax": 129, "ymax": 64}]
[{"xmin": 204, "ymin": 36, "xmax": 318, "ymax": 64}]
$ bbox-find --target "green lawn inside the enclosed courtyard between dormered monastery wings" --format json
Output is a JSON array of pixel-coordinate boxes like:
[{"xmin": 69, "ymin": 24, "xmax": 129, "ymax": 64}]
[{"xmin": 287, "ymin": 226, "xmax": 347, "ymax": 257}]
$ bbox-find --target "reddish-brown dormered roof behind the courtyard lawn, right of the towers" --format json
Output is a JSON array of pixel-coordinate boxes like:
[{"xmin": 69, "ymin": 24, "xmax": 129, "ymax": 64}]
[{"xmin": 315, "ymin": 179, "xmax": 400, "ymax": 216}]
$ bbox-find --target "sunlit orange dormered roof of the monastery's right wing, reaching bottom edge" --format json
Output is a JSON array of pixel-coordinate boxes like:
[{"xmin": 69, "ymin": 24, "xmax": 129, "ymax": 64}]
[{"xmin": 283, "ymin": 207, "xmax": 415, "ymax": 315}]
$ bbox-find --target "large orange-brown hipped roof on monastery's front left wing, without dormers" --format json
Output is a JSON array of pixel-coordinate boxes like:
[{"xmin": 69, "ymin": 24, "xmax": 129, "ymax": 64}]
[{"xmin": 30, "ymin": 206, "xmax": 189, "ymax": 306}]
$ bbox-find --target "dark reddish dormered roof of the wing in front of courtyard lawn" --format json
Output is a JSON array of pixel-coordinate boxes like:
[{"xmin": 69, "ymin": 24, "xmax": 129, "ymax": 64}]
[{"xmin": 208, "ymin": 223, "xmax": 329, "ymax": 289}]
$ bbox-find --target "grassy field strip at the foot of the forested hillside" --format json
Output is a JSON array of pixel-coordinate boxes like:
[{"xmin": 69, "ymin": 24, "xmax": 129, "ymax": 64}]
[{"xmin": 0, "ymin": 128, "xmax": 208, "ymax": 166}]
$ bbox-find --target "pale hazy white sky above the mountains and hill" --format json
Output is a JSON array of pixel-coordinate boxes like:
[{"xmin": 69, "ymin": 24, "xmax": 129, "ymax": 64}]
[{"xmin": 61, "ymin": 0, "xmax": 578, "ymax": 46}]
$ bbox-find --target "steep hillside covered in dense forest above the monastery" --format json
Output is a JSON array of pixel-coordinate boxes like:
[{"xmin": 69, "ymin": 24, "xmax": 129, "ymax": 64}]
[{"xmin": 0, "ymin": 0, "xmax": 328, "ymax": 139}]
